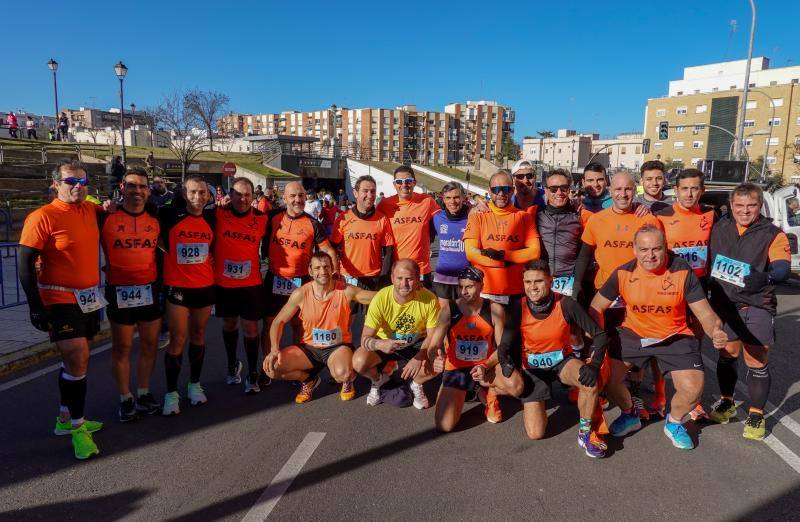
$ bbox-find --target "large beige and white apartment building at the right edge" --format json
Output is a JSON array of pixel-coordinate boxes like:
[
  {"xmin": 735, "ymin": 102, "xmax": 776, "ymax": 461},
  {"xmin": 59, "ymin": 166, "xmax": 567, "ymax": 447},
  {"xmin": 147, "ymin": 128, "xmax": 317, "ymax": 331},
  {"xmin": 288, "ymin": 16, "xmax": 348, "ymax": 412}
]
[{"xmin": 644, "ymin": 58, "xmax": 800, "ymax": 182}]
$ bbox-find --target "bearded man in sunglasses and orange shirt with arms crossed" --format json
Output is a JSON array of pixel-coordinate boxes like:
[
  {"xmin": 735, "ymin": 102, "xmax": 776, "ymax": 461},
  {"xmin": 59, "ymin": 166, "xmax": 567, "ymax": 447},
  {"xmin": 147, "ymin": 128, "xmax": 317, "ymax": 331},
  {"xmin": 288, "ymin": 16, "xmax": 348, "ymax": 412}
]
[{"xmin": 464, "ymin": 171, "xmax": 541, "ymax": 304}]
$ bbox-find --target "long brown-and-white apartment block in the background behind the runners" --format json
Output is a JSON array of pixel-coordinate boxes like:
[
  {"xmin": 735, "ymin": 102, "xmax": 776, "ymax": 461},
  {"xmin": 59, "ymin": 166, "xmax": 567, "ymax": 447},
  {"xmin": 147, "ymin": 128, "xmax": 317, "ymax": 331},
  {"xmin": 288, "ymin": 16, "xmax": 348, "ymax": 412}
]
[{"xmin": 219, "ymin": 101, "xmax": 515, "ymax": 165}]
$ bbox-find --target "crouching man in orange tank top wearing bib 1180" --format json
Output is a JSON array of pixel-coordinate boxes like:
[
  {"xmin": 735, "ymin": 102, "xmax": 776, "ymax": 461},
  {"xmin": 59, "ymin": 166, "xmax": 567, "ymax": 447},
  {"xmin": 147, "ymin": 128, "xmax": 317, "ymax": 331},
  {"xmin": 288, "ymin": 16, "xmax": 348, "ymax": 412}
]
[{"xmin": 264, "ymin": 252, "xmax": 375, "ymax": 404}]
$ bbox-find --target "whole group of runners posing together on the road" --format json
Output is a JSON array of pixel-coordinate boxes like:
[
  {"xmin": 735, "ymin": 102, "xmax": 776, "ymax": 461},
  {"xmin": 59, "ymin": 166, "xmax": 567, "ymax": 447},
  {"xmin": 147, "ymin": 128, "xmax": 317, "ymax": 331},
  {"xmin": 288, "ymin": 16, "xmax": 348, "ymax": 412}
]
[{"xmin": 20, "ymin": 156, "xmax": 790, "ymax": 459}]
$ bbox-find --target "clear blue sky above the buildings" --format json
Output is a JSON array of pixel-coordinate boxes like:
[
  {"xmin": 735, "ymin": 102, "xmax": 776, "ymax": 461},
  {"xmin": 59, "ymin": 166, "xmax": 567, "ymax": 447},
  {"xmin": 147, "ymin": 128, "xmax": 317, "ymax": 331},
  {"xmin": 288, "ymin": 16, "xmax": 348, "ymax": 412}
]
[{"xmin": 0, "ymin": 0, "xmax": 800, "ymax": 139}]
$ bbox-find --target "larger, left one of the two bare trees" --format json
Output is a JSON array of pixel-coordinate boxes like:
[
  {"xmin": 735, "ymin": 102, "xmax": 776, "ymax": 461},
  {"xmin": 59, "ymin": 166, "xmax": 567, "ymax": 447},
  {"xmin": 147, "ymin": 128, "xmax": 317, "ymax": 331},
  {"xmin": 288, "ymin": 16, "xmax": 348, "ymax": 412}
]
[{"xmin": 153, "ymin": 91, "xmax": 208, "ymax": 181}]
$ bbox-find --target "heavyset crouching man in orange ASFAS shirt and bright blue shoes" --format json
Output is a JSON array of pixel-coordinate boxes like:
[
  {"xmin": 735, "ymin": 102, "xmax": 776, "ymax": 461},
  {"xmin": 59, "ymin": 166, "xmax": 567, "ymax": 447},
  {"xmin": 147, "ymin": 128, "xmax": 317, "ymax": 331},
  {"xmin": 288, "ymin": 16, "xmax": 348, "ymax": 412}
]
[{"xmin": 590, "ymin": 225, "xmax": 728, "ymax": 449}]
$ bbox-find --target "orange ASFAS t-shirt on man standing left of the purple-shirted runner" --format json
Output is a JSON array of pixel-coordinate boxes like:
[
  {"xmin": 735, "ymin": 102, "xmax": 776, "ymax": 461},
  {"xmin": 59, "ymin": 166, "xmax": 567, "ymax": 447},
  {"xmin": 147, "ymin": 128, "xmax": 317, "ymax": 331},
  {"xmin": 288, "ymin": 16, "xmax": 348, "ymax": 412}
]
[{"xmin": 378, "ymin": 192, "xmax": 441, "ymax": 275}]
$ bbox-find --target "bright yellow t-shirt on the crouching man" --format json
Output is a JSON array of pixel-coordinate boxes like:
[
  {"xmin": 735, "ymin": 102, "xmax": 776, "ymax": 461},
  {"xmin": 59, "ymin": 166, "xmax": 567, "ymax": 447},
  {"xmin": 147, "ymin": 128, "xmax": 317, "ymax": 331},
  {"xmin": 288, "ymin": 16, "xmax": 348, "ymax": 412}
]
[{"xmin": 364, "ymin": 286, "xmax": 439, "ymax": 344}]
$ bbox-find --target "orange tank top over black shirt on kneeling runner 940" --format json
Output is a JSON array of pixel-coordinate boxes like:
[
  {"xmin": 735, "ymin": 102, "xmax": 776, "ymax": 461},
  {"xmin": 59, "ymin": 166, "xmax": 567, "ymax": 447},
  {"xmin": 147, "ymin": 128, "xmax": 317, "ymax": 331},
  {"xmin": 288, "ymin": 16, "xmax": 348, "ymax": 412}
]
[{"xmin": 519, "ymin": 295, "xmax": 572, "ymax": 368}]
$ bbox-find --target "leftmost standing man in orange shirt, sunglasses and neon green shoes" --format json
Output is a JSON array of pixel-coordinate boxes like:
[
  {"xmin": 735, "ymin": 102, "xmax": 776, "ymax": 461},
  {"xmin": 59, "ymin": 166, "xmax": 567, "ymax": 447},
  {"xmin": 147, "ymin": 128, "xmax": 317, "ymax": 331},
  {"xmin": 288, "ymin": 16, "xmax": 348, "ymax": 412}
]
[{"xmin": 19, "ymin": 157, "xmax": 106, "ymax": 459}]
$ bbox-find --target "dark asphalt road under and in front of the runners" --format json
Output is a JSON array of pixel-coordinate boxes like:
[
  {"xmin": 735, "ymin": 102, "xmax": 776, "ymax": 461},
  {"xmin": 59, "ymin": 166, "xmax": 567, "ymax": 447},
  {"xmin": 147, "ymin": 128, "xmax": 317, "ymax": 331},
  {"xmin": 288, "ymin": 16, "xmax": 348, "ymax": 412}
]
[{"xmin": 0, "ymin": 287, "xmax": 800, "ymax": 520}]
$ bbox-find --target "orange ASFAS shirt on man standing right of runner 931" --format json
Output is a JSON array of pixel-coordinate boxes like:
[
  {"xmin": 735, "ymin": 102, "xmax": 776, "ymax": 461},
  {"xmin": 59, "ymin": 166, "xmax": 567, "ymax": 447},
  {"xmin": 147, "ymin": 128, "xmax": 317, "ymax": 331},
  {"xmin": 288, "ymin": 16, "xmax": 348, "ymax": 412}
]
[{"xmin": 267, "ymin": 209, "xmax": 330, "ymax": 278}]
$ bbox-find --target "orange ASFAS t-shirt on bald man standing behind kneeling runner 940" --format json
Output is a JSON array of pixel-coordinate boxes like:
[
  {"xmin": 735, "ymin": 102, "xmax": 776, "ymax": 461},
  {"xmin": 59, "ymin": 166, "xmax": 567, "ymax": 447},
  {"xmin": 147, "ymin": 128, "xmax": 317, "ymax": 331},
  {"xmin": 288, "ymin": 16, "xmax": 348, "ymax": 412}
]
[{"xmin": 581, "ymin": 207, "xmax": 664, "ymax": 289}]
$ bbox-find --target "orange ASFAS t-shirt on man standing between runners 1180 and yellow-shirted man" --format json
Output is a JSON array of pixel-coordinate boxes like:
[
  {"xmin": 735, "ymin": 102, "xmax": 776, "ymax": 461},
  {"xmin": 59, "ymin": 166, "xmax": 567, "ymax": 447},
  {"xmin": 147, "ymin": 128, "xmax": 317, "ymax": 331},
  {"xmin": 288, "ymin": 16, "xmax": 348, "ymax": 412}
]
[{"xmin": 331, "ymin": 209, "xmax": 395, "ymax": 277}]
